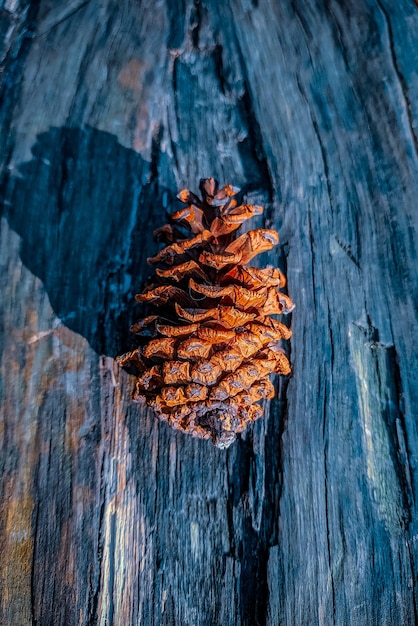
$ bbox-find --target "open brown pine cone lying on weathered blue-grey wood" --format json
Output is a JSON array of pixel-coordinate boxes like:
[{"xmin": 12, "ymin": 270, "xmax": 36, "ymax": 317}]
[{"xmin": 118, "ymin": 178, "xmax": 294, "ymax": 448}]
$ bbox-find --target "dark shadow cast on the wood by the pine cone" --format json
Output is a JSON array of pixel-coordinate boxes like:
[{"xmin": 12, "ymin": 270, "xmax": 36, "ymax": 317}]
[{"xmin": 1, "ymin": 128, "xmax": 171, "ymax": 356}]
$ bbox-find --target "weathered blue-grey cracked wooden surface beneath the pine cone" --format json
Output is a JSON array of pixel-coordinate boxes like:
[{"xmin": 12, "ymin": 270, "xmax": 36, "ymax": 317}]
[{"xmin": 0, "ymin": 0, "xmax": 418, "ymax": 626}]
